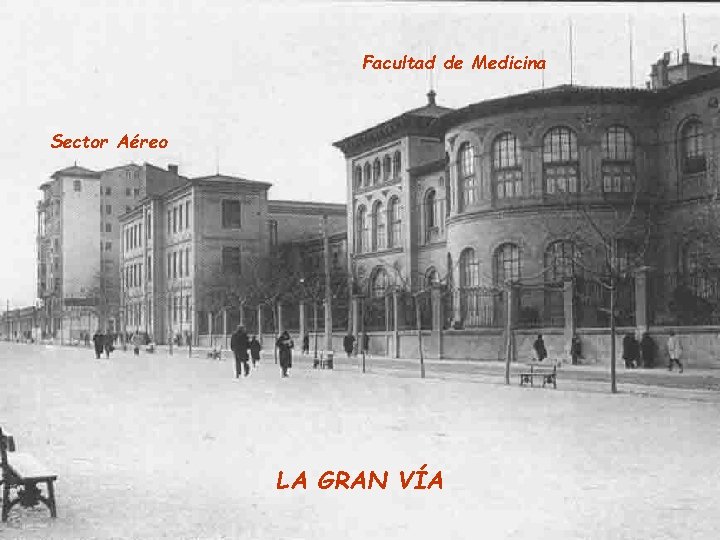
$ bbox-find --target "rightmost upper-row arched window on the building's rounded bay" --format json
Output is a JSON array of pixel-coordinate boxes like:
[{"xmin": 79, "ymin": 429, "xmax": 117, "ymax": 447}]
[{"xmin": 602, "ymin": 126, "xmax": 635, "ymax": 193}]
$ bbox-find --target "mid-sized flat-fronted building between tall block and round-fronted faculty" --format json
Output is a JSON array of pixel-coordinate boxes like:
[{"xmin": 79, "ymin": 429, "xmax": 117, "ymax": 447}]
[{"xmin": 120, "ymin": 175, "xmax": 346, "ymax": 344}]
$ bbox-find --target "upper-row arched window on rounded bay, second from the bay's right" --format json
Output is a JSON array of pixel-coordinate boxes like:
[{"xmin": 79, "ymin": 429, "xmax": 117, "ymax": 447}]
[{"xmin": 543, "ymin": 127, "xmax": 580, "ymax": 194}]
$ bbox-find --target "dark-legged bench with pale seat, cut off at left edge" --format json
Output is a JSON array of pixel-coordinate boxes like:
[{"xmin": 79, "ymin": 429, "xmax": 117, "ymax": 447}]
[{"xmin": 0, "ymin": 428, "xmax": 57, "ymax": 522}]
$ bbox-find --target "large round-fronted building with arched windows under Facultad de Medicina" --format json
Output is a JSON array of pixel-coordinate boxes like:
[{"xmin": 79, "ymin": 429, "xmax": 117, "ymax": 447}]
[{"xmin": 335, "ymin": 55, "xmax": 720, "ymax": 364}]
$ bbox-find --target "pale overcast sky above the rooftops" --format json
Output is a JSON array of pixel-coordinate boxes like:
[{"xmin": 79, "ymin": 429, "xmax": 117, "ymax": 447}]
[{"xmin": 0, "ymin": 0, "xmax": 720, "ymax": 306}]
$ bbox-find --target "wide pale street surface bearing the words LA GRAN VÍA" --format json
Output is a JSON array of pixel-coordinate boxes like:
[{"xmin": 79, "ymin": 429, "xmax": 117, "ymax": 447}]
[{"xmin": 0, "ymin": 343, "xmax": 720, "ymax": 540}]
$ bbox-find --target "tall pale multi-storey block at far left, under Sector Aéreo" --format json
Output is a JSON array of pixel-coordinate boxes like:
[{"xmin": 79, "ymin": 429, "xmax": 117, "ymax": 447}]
[{"xmin": 37, "ymin": 163, "xmax": 185, "ymax": 339}]
